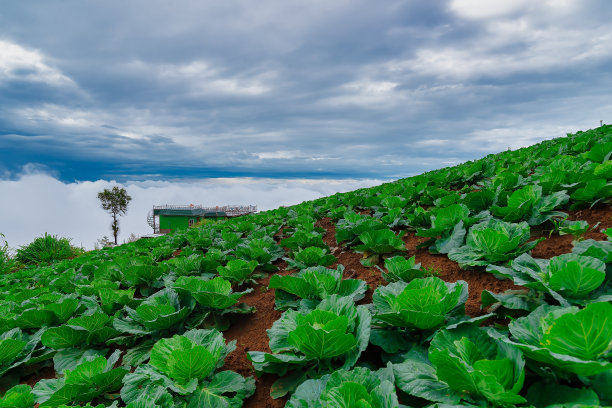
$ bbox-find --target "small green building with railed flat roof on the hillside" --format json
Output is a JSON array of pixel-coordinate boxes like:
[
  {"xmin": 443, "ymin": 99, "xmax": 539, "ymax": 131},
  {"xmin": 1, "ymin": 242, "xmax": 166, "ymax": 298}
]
[{"xmin": 147, "ymin": 204, "xmax": 257, "ymax": 234}]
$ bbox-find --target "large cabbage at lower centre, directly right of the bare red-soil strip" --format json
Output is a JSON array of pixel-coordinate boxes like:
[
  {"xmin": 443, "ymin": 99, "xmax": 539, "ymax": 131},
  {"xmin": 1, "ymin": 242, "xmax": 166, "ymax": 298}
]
[{"xmin": 247, "ymin": 295, "xmax": 371, "ymax": 398}]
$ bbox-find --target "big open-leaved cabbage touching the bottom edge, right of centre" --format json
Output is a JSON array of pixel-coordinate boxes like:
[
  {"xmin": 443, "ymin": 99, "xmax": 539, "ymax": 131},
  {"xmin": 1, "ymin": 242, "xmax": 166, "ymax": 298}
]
[{"xmin": 393, "ymin": 324, "xmax": 525, "ymax": 406}]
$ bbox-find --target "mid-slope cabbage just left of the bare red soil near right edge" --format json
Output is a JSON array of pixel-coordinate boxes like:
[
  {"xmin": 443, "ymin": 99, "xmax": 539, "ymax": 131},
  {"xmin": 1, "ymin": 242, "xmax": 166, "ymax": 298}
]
[{"xmin": 448, "ymin": 218, "xmax": 544, "ymax": 267}]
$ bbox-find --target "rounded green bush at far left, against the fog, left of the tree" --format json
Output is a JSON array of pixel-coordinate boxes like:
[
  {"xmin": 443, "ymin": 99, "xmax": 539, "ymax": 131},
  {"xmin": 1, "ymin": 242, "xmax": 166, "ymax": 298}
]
[{"xmin": 15, "ymin": 233, "xmax": 84, "ymax": 265}]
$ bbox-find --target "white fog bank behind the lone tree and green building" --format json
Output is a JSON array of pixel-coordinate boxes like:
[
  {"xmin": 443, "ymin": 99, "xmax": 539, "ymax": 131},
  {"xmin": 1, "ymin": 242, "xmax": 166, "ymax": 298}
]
[{"xmin": 0, "ymin": 172, "xmax": 382, "ymax": 249}]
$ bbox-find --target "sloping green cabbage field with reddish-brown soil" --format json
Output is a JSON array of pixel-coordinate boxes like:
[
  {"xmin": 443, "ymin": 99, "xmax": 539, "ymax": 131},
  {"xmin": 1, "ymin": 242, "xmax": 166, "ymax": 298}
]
[{"xmin": 0, "ymin": 126, "xmax": 612, "ymax": 408}]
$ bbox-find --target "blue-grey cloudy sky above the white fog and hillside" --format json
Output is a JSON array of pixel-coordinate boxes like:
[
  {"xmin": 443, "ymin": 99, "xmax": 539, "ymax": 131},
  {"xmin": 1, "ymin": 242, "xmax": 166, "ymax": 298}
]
[{"xmin": 0, "ymin": 0, "xmax": 612, "ymax": 249}]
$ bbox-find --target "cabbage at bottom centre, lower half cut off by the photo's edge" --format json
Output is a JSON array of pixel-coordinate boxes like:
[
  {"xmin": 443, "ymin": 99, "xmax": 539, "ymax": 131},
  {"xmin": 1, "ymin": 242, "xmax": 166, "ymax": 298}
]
[{"xmin": 285, "ymin": 366, "xmax": 399, "ymax": 408}]
